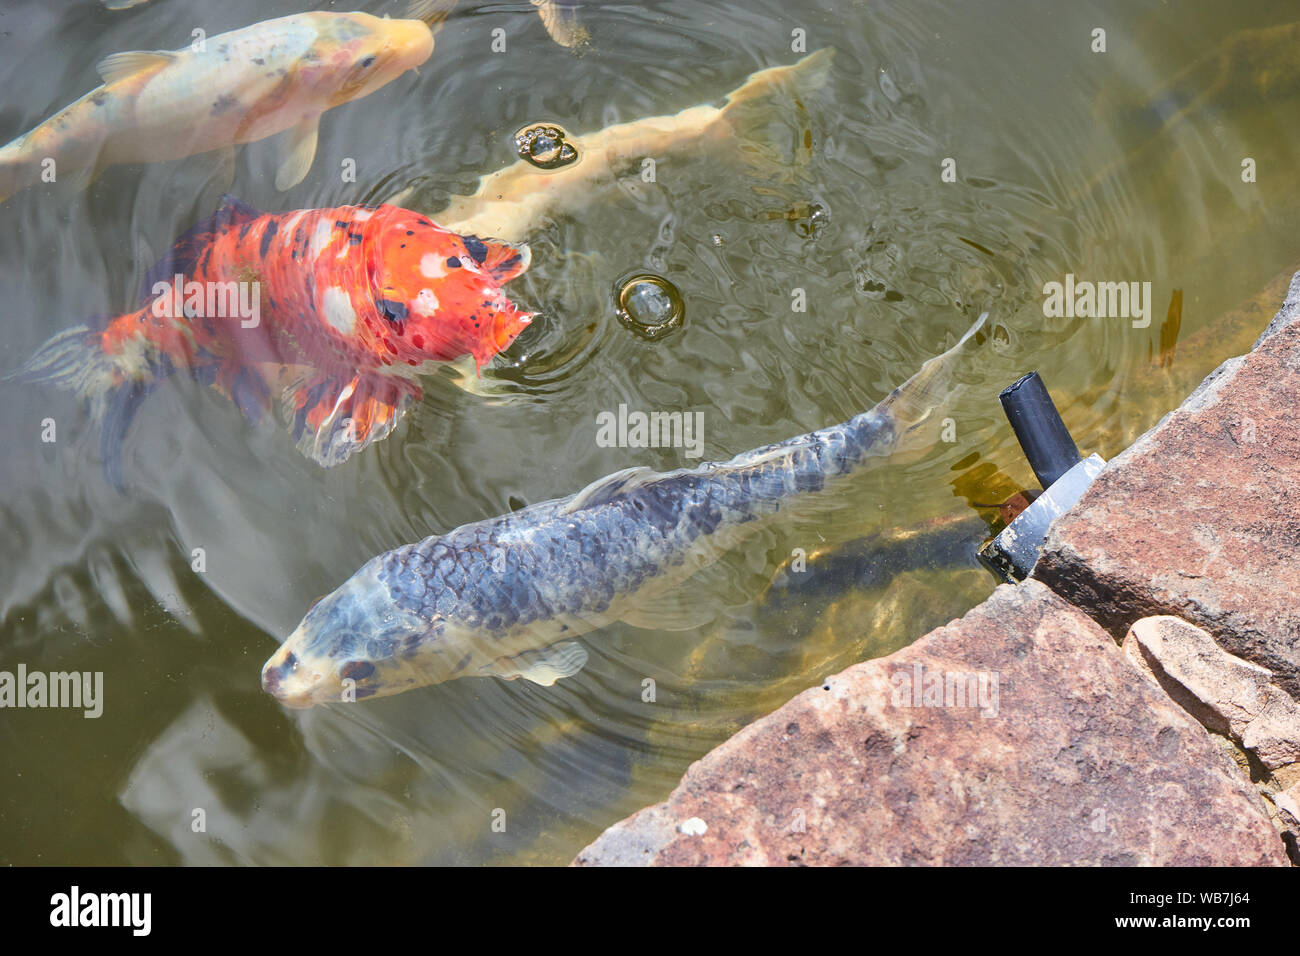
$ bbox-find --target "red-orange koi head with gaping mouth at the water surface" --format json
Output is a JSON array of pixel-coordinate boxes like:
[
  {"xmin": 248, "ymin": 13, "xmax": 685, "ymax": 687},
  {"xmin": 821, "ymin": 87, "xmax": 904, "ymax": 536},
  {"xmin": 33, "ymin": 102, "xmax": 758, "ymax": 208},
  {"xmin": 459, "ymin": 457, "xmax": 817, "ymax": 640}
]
[{"xmin": 368, "ymin": 207, "xmax": 533, "ymax": 368}]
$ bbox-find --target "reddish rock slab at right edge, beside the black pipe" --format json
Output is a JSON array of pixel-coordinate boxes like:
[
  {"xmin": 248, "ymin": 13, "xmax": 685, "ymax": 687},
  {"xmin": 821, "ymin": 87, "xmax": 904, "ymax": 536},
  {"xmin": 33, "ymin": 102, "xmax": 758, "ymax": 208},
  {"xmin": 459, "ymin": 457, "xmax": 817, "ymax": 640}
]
[{"xmin": 1034, "ymin": 276, "xmax": 1300, "ymax": 698}]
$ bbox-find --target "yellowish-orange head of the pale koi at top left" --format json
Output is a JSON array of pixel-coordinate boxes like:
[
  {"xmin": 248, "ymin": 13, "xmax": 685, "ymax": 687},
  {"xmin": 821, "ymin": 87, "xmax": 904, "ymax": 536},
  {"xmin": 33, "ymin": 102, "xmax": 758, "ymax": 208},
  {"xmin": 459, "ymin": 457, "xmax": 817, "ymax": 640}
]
[{"xmin": 312, "ymin": 13, "xmax": 433, "ymax": 107}]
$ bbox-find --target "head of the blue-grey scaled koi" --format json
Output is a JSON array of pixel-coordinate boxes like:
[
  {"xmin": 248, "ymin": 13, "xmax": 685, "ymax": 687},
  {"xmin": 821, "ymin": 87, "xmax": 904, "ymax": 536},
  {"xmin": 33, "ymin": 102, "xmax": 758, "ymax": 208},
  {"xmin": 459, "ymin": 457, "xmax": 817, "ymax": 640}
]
[{"xmin": 261, "ymin": 553, "xmax": 451, "ymax": 709}]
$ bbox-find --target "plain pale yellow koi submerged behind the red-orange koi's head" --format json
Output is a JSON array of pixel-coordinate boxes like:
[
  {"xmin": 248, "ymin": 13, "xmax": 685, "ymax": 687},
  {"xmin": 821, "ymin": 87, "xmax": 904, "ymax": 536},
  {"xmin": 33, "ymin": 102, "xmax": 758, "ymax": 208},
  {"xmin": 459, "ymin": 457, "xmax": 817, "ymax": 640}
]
[{"xmin": 403, "ymin": 47, "xmax": 835, "ymax": 242}]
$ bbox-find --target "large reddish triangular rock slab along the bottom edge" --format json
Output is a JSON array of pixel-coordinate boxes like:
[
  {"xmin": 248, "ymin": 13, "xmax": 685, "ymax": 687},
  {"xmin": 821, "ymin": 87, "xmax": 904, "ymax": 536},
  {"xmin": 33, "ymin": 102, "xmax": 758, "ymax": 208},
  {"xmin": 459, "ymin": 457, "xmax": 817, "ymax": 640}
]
[{"xmin": 575, "ymin": 581, "xmax": 1287, "ymax": 865}]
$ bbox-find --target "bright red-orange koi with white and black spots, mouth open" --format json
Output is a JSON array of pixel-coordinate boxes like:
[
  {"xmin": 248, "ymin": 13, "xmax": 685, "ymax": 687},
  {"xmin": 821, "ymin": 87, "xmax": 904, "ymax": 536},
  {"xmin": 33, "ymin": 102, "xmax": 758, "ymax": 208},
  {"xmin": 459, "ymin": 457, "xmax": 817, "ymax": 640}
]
[{"xmin": 10, "ymin": 196, "xmax": 533, "ymax": 489}]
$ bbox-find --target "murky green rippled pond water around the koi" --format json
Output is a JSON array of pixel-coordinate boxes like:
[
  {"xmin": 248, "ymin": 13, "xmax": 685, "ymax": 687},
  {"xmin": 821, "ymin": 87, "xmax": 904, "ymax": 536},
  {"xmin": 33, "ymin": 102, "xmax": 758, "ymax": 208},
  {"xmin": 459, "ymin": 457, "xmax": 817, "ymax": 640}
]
[{"xmin": 0, "ymin": 0, "xmax": 1300, "ymax": 864}]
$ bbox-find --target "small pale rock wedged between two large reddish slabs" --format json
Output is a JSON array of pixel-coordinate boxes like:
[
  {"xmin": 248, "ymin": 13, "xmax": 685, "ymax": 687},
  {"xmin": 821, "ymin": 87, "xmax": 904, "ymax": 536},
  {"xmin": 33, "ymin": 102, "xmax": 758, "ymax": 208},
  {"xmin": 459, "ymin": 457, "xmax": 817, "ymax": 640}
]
[{"xmin": 1125, "ymin": 615, "xmax": 1300, "ymax": 770}]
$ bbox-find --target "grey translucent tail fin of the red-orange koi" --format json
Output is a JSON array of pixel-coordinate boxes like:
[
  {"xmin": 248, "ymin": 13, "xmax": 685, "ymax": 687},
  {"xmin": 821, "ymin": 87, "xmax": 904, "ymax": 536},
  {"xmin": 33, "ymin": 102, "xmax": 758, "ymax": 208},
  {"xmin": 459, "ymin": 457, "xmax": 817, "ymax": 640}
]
[{"xmin": 4, "ymin": 325, "xmax": 163, "ymax": 492}]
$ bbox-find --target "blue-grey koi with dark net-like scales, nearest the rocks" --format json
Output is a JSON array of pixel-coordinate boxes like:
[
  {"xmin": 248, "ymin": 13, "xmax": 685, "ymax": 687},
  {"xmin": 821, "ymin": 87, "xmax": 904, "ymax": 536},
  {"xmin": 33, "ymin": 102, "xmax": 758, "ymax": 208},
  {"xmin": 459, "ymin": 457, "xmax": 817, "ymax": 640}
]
[{"xmin": 261, "ymin": 310, "xmax": 984, "ymax": 708}]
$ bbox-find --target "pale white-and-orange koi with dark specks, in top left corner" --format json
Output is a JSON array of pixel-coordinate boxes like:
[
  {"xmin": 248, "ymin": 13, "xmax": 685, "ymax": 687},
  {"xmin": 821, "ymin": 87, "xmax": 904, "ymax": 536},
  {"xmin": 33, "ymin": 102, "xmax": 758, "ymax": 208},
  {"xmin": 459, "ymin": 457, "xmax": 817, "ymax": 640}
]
[{"xmin": 0, "ymin": 0, "xmax": 446, "ymax": 202}]
